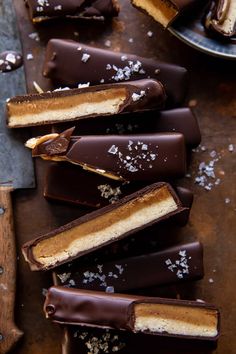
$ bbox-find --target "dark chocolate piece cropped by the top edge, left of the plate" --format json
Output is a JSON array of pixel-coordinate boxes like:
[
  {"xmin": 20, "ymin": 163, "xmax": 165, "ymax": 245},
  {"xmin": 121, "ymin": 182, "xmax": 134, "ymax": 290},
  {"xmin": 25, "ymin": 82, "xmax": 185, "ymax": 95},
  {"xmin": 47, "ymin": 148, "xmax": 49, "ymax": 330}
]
[{"xmin": 25, "ymin": 0, "xmax": 120, "ymax": 23}]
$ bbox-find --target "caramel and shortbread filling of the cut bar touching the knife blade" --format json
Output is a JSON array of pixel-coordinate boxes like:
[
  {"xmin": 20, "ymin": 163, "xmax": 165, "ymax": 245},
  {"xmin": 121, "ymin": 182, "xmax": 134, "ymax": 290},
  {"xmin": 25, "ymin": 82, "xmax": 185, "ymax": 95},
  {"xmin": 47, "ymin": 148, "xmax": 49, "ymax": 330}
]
[{"xmin": 7, "ymin": 87, "xmax": 128, "ymax": 127}]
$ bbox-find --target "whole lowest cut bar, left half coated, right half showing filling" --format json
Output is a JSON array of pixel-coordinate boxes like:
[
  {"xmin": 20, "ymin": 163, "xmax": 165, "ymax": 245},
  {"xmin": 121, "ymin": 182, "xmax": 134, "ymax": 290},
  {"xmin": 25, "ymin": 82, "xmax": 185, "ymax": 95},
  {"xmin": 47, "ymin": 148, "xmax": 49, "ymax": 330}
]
[{"xmin": 44, "ymin": 287, "xmax": 219, "ymax": 340}]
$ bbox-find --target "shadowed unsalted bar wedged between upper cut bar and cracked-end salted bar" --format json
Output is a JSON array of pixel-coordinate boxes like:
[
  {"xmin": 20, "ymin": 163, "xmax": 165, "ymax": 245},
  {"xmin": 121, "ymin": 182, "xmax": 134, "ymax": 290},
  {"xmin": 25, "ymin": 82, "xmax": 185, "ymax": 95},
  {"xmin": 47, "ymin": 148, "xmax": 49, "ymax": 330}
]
[{"xmin": 52, "ymin": 108, "xmax": 201, "ymax": 150}]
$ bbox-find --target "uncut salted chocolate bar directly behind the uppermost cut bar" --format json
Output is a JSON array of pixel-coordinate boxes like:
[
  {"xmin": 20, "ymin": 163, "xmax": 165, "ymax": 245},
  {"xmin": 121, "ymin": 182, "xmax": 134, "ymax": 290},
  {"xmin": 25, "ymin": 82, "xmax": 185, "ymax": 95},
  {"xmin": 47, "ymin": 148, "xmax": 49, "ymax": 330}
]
[{"xmin": 43, "ymin": 39, "xmax": 187, "ymax": 106}]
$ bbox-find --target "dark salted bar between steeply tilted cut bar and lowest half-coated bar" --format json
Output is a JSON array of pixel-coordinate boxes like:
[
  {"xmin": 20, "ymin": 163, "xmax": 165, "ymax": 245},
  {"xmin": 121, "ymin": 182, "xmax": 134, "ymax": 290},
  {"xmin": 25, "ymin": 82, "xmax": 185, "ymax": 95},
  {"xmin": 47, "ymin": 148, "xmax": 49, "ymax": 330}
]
[{"xmin": 53, "ymin": 242, "xmax": 204, "ymax": 292}]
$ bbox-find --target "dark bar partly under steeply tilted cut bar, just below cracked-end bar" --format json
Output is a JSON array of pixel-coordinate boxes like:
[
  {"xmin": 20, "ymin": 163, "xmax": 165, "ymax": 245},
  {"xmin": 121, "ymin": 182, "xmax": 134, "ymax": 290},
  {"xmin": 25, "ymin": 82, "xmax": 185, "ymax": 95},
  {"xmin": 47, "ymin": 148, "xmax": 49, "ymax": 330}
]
[{"xmin": 44, "ymin": 163, "xmax": 193, "ymax": 225}]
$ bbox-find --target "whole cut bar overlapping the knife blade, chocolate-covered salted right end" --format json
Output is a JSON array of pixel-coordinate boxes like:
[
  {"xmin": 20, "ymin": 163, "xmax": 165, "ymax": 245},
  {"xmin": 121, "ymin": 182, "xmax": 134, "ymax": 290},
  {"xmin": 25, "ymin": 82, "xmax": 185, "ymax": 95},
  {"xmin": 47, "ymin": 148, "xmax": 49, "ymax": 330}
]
[{"xmin": 7, "ymin": 79, "xmax": 166, "ymax": 128}]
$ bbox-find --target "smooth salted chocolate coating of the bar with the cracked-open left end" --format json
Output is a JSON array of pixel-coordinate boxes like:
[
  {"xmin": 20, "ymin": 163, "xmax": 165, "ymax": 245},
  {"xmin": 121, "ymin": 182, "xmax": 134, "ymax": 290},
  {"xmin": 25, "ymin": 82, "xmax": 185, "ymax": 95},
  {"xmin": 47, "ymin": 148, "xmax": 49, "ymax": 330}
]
[{"xmin": 66, "ymin": 133, "xmax": 186, "ymax": 181}]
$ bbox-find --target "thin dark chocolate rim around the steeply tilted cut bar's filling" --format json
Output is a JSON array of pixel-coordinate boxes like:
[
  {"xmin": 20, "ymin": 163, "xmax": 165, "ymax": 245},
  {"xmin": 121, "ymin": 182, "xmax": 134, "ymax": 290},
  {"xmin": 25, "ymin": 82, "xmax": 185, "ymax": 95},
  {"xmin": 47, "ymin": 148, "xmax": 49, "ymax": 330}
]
[{"xmin": 22, "ymin": 182, "xmax": 184, "ymax": 270}]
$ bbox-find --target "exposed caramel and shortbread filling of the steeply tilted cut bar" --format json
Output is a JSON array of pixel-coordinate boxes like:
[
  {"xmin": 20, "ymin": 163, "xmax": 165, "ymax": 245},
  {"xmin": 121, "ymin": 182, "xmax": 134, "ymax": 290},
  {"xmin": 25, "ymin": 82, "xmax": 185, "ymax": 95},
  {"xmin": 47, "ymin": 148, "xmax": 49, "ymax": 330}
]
[{"xmin": 32, "ymin": 186, "xmax": 178, "ymax": 267}]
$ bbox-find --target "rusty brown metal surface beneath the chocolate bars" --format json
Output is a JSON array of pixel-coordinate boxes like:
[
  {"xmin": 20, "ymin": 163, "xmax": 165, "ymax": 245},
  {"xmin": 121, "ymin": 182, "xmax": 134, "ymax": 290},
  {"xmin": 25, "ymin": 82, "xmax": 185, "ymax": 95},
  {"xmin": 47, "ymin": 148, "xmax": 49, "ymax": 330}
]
[{"xmin": 0, "ymin": 0, "xmax": 236, "ymax": 354}]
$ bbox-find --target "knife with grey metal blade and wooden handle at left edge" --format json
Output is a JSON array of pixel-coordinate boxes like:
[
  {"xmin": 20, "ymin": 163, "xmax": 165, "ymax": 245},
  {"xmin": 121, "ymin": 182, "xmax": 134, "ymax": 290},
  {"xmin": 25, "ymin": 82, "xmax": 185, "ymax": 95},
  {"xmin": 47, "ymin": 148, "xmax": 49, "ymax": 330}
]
[{"xmin": 0, "ymin": 0, "xmax": 35, "ymax": 354}]
